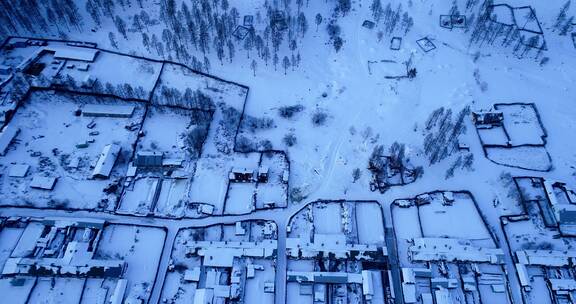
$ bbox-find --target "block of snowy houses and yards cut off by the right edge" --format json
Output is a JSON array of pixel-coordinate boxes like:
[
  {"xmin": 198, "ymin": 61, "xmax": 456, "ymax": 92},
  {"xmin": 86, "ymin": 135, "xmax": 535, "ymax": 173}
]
[{"xmin": 501, "ymin": 177, "xmax": 576, "ymax": 303}]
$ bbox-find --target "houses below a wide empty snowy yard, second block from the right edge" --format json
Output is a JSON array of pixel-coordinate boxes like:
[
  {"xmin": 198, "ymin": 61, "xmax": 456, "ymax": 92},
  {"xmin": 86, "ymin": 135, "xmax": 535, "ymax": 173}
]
[{"xmin": 392, "ymin": 192, "xmax": 510, "ymax": 304}]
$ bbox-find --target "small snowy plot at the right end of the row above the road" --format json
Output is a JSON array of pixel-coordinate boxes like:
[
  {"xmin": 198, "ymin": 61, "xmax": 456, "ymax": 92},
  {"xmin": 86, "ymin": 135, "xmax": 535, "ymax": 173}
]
[{"xmin": 256, "ymin": 153, "xmax": 289, "ymax": 209}]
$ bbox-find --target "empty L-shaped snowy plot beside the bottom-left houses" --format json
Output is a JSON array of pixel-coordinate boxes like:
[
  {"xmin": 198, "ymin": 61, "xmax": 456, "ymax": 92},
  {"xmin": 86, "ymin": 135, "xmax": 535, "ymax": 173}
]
[{"xmin": 95, "ymin": 225, "xmax": 166, "ymax": 303}]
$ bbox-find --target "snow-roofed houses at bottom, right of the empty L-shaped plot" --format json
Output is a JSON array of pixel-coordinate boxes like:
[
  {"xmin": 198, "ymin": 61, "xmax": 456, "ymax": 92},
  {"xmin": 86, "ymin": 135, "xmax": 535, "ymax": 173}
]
[{"xmin": 164, "ymin": 221, "xmax": 277, "ymax": 304}]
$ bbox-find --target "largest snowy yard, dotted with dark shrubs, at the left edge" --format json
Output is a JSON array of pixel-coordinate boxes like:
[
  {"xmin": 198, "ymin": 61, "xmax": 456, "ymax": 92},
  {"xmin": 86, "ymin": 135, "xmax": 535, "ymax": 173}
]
[{"xmin": 0, "ymin": 93, "xmax": 144, "ymax": 210}]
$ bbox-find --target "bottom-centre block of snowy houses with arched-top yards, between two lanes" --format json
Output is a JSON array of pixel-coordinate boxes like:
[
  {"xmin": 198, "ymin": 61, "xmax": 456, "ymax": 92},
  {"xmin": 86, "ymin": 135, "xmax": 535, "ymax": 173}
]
[{"xmin": 286, "ymin": 202, "xmax": 393, "ymax": 303}]
